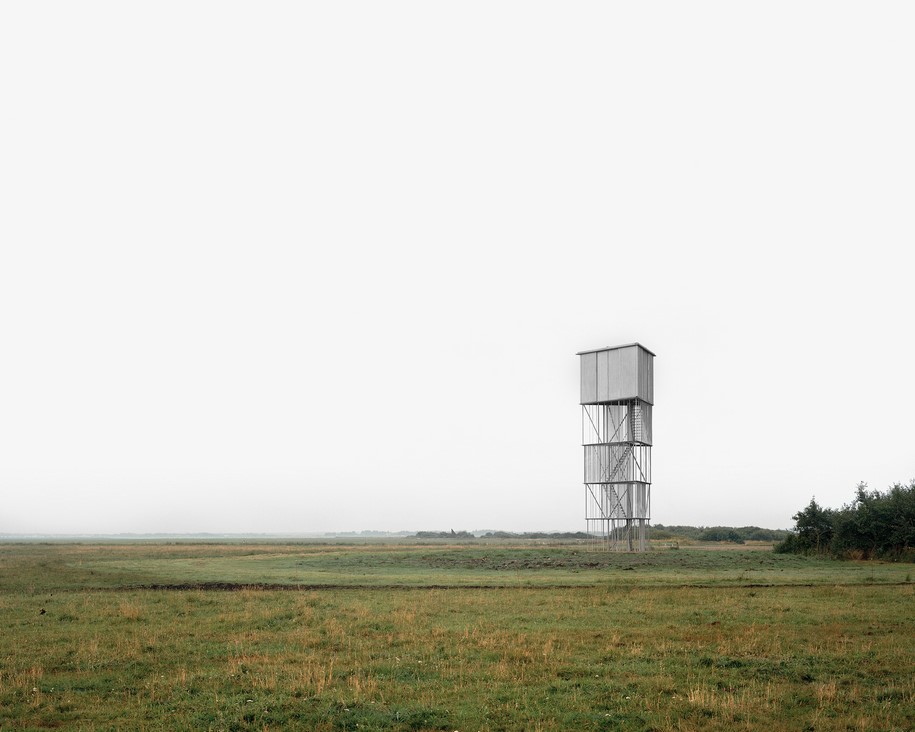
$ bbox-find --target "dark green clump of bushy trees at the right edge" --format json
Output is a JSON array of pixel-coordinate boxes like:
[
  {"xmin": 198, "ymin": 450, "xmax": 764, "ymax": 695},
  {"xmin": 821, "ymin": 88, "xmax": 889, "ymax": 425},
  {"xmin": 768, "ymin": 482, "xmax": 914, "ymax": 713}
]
[{"xmin": 775, "ymin": 479, "xmax": 915, "ymax": 561}]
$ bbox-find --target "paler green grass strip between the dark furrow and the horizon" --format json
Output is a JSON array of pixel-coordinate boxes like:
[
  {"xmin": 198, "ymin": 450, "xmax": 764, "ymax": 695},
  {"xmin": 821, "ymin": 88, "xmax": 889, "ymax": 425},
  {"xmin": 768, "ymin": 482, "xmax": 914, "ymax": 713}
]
[{"xmin": 0, "ymin": 542, "xmax": 911, "ymax": 591}]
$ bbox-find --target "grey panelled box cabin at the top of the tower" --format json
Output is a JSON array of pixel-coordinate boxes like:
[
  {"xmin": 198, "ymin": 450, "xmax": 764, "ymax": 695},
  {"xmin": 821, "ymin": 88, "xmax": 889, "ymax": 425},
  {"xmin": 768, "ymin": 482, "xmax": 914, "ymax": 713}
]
[{"xmin": 578, "ymin": 343, "xmax": 654, "ymax": 404}]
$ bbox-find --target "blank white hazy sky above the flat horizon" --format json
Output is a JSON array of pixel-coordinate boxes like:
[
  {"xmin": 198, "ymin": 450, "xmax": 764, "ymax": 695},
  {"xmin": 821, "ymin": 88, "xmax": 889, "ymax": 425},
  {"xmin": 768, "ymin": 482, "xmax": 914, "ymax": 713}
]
[{"xmin": 0, "ymin": 0, "xmax": 915, "ymax": 533}]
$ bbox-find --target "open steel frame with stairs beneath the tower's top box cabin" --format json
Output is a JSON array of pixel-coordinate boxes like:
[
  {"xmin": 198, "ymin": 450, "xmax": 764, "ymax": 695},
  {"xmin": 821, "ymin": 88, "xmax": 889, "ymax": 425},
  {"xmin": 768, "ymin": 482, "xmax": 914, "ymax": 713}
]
[{"xmin": 581, "ymin": 398, "xmax": 652, "ymax": 551}]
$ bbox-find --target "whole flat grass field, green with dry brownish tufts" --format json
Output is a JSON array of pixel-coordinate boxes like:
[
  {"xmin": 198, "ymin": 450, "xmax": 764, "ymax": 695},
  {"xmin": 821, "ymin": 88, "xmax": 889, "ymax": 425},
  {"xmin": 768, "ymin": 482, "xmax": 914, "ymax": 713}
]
[{"xmin": 0, "ymin": 542, "xmax": 915, "ymax": 731}]
